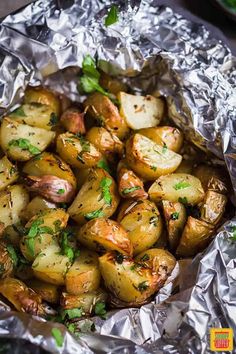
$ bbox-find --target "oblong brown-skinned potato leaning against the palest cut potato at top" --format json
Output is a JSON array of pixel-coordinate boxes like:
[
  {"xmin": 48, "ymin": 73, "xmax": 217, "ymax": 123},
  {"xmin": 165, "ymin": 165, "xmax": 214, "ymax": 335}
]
[{"xmin": 84, "ymin": 92, "xmax": 129, "ymax": 139}]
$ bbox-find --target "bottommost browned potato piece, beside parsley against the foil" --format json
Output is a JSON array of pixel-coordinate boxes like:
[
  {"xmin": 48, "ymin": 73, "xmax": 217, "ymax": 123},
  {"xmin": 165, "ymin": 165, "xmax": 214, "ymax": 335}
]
[{"xmin": 60, "ymin": 289, "xmax": 107, "ymax": 315}]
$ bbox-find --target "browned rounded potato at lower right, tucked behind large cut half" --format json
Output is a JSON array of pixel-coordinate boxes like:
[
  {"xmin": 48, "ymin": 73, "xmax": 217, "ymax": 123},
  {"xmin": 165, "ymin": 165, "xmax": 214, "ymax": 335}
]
[{"xmin": 135, "ymin": 248, "xmax": 176, "ymax": 280}]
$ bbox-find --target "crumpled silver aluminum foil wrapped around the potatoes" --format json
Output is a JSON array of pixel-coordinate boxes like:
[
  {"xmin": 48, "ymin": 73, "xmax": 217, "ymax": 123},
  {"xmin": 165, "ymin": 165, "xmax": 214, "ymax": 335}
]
[{"xmin": 0, "ymin": 0, "xmax": 236, "ymax": 354}]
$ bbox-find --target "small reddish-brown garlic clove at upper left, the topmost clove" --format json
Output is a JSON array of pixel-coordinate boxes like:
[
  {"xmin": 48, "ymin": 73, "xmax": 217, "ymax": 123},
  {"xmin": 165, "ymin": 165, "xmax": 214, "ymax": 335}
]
[{"xmin": 60, "ymin": 108, "xmax": 86, "ymax": 134}]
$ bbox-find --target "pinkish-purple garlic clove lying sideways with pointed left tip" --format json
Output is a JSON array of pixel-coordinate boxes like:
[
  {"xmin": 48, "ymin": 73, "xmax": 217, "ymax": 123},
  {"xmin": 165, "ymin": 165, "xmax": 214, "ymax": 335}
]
[{"xmin": 25, "ymin": 175, "xmax": 75, "ymax": 203}]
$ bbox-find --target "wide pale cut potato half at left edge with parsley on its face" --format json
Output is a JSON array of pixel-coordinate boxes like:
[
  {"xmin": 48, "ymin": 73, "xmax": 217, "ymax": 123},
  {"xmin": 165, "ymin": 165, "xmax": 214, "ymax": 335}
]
[{"xmin": 0, "ymin": 117, "xmax": 55, "ymax": 161}]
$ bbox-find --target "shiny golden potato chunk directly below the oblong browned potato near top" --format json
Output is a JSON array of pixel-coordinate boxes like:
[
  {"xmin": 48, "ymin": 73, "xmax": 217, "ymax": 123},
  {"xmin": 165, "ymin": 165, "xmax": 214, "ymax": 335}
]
[{"xmin": 86, "ymin": 127, "xmax": 124, "ymax": 161}]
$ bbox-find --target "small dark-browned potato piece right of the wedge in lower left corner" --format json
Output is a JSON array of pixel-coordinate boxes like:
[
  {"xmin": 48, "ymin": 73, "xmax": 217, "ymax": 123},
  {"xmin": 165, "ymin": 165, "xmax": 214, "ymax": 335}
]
[{"xmin": 27, "ymin": 279, "xmax": 60, "ymax": 304}]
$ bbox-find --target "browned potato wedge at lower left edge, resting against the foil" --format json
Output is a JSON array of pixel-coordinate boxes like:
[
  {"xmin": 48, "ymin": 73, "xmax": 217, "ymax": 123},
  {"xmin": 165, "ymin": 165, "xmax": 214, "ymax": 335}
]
[{"xmin": 0, "ymin": 278, "xmax": 45, "ymax": 316}]
